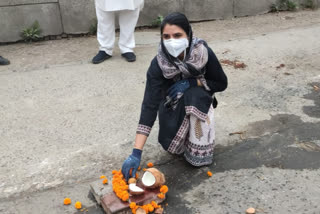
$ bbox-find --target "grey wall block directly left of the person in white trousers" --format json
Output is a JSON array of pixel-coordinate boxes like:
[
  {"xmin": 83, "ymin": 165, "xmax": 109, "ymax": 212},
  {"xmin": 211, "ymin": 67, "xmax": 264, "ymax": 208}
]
[{"xmin": 59, "ymin": 0, "xmax": 96, "ymax": 34}]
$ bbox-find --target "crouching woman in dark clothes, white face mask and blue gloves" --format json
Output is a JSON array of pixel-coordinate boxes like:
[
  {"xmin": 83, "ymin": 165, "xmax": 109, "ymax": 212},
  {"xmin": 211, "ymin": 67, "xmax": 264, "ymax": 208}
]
[{"xmin": 122, "ymin": 13, "xmax": 227, "ymax": 179}]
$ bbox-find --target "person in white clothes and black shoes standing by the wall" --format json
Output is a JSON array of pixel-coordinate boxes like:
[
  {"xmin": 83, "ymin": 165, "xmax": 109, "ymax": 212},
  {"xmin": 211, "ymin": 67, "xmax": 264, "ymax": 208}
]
[{"xmin": 92, "ymin": 0, "xmax": 144, "ymax": 64}]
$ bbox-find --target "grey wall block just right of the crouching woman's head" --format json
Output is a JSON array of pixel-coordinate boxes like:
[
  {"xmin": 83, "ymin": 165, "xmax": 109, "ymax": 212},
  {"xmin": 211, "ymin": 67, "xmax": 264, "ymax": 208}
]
[{"xmin": 183, "ymin": 0, "xmax": 233, "ymax": 21}]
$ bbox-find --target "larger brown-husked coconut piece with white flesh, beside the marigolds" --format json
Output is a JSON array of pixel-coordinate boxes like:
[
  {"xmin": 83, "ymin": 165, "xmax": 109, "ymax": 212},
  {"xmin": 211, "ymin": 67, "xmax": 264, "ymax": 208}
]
[{"xmin": 141, "ymin": 168, "xmax": 166, "ymax": 189}]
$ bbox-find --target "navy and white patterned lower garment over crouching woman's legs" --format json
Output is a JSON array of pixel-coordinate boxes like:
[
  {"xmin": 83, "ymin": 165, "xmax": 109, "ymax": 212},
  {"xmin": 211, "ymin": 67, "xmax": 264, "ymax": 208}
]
[{"xmin": 158, "ymin": 87, "xmax": 215, "ymax": 166}]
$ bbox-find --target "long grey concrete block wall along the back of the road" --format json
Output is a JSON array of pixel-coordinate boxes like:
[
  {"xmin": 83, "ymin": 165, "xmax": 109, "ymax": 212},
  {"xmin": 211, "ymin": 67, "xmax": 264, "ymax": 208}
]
[{"xmin": 0, "ymin": 0, "xmax": 320, "ymax": 42}]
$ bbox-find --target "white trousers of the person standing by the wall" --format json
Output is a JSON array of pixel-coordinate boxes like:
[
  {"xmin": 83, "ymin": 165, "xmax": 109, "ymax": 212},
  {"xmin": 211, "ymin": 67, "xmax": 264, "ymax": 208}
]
[{"xmin": 96, "ymin": 7, "xmax": 140, "ymax": 55}]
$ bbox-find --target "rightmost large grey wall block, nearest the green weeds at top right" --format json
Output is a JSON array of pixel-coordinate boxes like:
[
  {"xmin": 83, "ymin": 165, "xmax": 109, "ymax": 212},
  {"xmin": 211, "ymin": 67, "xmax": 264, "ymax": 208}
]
[{"xmin": 233, "ymin": 0, "xmax": 276, "ymax": 17}]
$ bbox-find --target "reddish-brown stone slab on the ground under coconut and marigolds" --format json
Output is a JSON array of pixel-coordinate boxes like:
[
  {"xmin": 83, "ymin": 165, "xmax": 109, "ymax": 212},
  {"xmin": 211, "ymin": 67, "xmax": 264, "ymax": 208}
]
[{"xmin": 101, "ymin": 181, "xmax": 165, "ymax": 214}]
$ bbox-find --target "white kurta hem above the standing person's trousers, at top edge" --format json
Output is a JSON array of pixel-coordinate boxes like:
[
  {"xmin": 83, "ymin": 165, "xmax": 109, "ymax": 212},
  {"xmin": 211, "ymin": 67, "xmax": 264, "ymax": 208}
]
[{"xmin": 95, "ymin": 0, "xmax": 144, "ymax": 11}]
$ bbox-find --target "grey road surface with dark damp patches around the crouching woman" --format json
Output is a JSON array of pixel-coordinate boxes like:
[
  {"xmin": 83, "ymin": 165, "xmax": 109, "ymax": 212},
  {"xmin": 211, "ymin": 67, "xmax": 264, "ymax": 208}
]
[{"xmin": 0, "ymin": 10, "xmax": 320, "ymax": 214}]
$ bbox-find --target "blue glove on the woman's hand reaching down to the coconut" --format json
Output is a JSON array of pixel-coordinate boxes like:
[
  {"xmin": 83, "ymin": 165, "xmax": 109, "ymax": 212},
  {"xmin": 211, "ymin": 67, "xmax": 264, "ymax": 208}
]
[{"xmin": 121, "ymin": 149, "xmax": 142, "ymax": 181}]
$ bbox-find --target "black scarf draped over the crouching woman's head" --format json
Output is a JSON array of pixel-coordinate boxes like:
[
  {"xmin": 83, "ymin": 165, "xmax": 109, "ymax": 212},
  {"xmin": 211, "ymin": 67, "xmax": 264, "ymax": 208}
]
[{"xmin": 160, "ymin": 12, "xmax": 193, "ymax": 67}]
